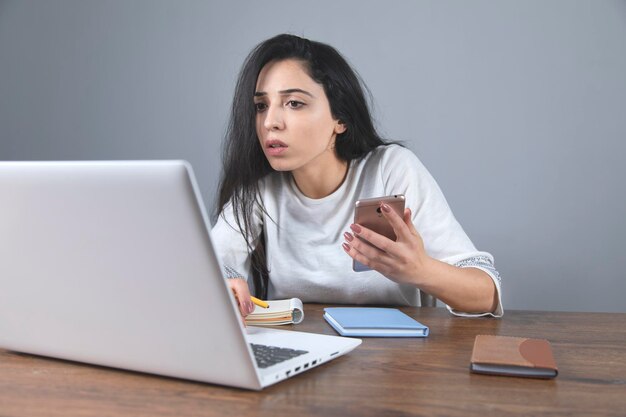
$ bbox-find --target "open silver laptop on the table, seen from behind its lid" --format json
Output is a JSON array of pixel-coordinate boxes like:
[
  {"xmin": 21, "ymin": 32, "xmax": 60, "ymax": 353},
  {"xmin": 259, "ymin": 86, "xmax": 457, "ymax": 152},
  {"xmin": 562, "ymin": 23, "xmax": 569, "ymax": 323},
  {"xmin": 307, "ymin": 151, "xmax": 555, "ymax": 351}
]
[{"xmin": 0, "ymin": 161, "xmax": 361, "ymax": 389}]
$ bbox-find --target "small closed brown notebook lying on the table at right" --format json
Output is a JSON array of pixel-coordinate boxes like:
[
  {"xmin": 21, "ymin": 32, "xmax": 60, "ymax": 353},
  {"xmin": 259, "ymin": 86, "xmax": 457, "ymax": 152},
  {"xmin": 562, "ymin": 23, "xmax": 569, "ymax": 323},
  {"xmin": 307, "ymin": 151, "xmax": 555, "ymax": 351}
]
[{"xmin": 470, "ymin": 335, "xmax": 558, "ymax": 378}]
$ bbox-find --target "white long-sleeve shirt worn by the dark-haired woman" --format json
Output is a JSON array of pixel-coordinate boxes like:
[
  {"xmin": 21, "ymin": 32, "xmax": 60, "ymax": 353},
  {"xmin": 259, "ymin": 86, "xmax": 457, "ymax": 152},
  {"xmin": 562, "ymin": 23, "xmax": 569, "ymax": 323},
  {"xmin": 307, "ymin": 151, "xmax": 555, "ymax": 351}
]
[{"xmin": 212, "ymin": 145, "xmax": 503, "ymax": 317}]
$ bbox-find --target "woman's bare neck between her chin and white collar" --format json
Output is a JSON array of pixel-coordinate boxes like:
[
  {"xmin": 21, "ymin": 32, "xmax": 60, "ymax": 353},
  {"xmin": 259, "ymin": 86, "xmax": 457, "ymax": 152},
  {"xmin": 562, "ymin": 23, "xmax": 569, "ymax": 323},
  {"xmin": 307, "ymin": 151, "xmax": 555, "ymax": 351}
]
[{"xmin": 291, "ymin": 159, "xmax": 348, "ymax": 199}]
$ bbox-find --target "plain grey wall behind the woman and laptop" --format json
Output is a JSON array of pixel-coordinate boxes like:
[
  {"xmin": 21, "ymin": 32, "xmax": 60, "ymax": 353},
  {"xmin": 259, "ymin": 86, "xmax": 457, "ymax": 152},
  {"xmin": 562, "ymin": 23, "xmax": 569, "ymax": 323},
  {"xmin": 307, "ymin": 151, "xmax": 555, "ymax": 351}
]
[{"xmin": 0, "ymin": 0, "xmax": 626, "ymax": 312}]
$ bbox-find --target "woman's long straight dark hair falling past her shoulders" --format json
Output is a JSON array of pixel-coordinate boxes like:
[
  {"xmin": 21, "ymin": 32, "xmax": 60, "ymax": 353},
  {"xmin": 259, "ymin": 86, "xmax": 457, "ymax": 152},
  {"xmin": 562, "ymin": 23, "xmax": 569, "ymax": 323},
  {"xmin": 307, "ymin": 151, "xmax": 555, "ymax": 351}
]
[{"xmin": 217, "ymin": 34, "xmax": 387, "ymax": 298}]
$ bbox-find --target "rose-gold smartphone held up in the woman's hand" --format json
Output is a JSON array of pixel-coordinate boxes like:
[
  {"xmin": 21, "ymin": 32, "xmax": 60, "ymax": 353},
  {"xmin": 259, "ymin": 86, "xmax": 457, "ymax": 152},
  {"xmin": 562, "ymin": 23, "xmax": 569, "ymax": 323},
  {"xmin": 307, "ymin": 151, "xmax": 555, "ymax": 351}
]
[{"xmin": 352, "ymin": 194, "xmax": 404, "ymax": 272}]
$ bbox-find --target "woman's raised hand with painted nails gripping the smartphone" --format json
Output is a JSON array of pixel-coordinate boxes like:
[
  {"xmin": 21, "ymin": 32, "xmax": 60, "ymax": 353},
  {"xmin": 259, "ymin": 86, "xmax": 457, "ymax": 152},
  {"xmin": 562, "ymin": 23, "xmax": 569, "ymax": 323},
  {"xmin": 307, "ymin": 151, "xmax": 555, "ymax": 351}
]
[{"xmin": 342, "ymin": 204, "xmax": 430, "ymax": 286}]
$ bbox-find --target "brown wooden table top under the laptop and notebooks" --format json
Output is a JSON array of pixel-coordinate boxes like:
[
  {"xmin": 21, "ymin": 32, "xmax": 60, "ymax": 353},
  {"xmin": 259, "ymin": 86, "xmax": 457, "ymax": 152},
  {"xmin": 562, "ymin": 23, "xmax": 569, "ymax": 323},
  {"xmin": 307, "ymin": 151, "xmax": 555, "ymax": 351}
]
[{"xmin": 0, "ymin": 304, "xmax": 626, "ymax": 417}]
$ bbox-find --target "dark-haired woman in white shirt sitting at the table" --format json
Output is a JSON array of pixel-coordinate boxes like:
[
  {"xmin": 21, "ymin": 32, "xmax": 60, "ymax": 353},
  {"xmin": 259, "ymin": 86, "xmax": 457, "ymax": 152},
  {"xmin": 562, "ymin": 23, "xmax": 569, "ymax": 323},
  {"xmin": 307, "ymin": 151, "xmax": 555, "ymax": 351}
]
[{"xmin": 212, "ymin": 35, "xmax": 502, "ymax": 316}]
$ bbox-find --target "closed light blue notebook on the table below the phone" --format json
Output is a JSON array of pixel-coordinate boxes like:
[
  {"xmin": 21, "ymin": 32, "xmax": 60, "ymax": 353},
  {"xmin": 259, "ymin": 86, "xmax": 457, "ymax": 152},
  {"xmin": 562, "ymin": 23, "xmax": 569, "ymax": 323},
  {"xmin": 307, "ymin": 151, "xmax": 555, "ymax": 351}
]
[{"xmin": 324, "ymin": 307, "xmax": 428, "ymax": 337}]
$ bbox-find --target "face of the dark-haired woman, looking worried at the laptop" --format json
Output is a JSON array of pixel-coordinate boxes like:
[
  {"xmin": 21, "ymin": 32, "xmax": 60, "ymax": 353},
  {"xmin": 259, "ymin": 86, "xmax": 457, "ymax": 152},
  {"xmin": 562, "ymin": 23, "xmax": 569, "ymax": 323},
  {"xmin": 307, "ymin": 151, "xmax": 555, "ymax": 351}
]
[{"xmin": 254, "ymin": 59, "xmax": 345, "ymax": 174}]
